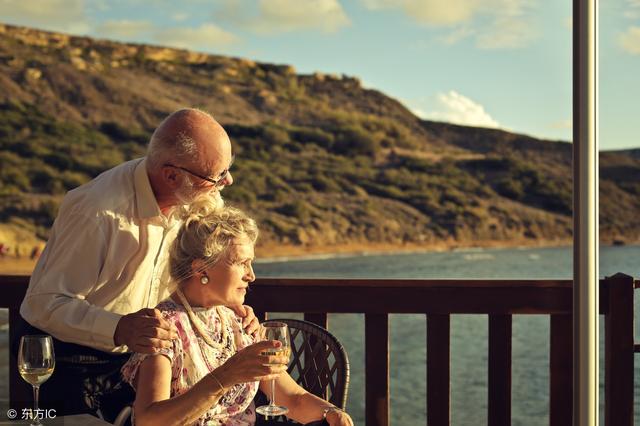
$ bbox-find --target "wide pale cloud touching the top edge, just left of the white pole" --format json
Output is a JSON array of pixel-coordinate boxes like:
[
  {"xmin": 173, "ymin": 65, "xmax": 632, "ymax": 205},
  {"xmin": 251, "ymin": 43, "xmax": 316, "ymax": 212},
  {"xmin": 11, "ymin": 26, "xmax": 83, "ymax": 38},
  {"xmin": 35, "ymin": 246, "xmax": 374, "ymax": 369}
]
[{"xmin": 361, "ymin": 0, "xmax": 538, "ymax": 49}]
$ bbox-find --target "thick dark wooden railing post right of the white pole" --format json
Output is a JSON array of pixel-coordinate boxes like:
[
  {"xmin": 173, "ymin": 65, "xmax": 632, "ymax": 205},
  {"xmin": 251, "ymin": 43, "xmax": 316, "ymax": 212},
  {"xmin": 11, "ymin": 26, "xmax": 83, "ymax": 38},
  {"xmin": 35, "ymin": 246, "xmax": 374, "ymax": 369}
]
[{"xmin": 604, "ymin": 273, "xmax": 634, "ymax": 426}]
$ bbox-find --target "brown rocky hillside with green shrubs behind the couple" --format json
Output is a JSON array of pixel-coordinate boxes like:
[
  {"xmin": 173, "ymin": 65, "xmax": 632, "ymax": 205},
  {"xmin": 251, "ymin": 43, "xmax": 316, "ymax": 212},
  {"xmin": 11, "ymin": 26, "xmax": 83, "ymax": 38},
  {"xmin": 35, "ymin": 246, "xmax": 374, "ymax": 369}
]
[{"xmin": 0, "ymin": 25, "xmax": 640, "ymax": 255}]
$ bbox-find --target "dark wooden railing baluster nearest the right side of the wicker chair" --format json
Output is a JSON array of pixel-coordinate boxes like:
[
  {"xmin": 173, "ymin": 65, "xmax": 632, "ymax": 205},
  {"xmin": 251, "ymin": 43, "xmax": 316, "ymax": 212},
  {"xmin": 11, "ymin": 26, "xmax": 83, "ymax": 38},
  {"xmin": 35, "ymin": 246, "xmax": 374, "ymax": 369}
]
[{"xmin": 364, "ymin": 314, "xmax": 390, "ymax": 426}]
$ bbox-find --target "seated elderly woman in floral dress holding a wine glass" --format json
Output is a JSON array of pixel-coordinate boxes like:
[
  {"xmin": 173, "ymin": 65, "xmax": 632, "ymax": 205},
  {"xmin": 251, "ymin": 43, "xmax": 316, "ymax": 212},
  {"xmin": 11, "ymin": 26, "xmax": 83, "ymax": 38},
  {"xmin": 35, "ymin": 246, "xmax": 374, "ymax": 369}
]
[{"xmin": 117, "ymin": 204, "xmax": 353, "ymax": 426}]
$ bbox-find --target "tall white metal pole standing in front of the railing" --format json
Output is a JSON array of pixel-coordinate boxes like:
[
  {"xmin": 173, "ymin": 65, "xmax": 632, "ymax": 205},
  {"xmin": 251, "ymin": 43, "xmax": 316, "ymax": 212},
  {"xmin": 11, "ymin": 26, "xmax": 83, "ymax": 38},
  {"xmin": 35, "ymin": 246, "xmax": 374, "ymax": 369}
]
[{"xmin": 573, "ymin": 0, "xmax": 599, "ymax": 426}]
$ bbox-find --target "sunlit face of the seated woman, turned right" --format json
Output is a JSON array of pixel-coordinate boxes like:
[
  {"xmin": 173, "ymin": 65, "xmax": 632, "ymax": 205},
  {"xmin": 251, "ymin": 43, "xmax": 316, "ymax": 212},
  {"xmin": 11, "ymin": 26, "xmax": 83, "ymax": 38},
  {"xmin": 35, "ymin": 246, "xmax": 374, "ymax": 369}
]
[{"xmin": 207, "ymin": 237, "xmax": 256, "ymax": 306}]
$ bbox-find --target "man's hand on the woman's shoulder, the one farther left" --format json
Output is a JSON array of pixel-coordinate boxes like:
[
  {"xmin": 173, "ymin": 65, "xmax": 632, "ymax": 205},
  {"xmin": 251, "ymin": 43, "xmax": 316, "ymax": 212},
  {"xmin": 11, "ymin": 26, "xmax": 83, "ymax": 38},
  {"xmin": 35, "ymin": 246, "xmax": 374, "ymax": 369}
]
[{"xmin": 113, "ymin": 309, "xmax": 179, "ymax": 354}]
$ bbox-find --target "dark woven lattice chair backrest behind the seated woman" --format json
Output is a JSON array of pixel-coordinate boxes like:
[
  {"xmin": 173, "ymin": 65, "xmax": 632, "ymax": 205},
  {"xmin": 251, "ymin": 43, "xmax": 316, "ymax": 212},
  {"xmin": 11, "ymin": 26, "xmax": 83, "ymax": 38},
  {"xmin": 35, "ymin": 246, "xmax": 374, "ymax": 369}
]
[{"xmin": 276, "ymin": 318, "xmax": 349, "ymax": 409}]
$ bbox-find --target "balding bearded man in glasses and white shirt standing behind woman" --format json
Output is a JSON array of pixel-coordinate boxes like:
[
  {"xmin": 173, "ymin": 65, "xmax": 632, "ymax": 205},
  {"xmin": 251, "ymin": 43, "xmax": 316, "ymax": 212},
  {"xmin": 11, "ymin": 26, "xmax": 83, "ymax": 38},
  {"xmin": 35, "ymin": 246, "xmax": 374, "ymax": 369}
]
[{"xmin": 20, "ymin": 109, "xmax": 257, "ymax": 418}]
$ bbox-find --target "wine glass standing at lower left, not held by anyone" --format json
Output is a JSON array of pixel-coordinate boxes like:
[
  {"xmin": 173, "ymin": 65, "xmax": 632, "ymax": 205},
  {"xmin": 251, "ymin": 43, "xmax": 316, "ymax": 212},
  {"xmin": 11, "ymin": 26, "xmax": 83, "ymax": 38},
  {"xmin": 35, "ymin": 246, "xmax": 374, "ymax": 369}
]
[{"xmin": 18, "ymin": 334, "xmax": 56, "ymax": 426}]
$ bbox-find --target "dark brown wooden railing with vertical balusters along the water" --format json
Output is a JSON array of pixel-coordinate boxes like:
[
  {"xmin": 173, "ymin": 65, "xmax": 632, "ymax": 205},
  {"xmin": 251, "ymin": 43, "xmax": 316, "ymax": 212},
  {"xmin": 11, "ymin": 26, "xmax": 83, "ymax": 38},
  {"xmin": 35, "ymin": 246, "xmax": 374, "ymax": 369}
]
[{"xmin": 0, "ymin": 274, "xmax": 634, "ymax": 426}]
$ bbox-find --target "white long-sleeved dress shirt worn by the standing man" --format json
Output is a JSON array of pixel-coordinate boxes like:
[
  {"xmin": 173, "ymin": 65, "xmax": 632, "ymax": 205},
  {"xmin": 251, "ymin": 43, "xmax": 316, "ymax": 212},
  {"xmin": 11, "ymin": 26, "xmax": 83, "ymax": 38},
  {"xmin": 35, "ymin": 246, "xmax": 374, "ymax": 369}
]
[{"xmin": 20, "ymin": 159, "xmax": 179, "ymax": 352}]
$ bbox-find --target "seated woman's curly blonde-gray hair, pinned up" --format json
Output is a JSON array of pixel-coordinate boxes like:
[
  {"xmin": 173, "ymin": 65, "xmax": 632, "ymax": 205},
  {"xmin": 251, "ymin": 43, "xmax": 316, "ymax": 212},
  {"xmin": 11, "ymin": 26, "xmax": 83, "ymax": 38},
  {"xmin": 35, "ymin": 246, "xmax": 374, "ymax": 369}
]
[{"xmin": 169, "ymin": 200, "xmax": 258, "ymax": 284}]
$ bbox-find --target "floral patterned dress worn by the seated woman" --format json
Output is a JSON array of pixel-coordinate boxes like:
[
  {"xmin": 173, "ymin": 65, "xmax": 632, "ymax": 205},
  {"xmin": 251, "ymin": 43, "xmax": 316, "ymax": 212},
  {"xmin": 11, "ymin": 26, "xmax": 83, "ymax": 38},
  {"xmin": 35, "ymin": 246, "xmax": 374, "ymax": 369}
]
[{"xmin": 122, "ymin": 299, "xmax": 258, "ymax": 426}]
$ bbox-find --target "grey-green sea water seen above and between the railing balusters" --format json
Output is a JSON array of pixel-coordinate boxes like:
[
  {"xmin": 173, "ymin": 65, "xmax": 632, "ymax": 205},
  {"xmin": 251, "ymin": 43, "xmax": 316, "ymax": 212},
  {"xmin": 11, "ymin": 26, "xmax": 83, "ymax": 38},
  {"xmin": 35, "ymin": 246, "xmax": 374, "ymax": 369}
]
[{"xmin": 0, "ymin": 246, "xmax": 640, "ymax": 426}]
